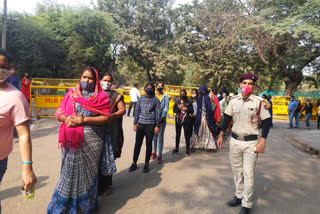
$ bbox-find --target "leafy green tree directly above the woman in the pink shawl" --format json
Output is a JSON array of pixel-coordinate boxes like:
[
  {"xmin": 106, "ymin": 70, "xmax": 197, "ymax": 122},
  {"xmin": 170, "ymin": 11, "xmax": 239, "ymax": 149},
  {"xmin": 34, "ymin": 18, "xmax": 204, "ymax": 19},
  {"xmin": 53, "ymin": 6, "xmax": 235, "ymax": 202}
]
[{"xmin": 37, "ymin": 5, "xmax": 117, "ymax": 76}]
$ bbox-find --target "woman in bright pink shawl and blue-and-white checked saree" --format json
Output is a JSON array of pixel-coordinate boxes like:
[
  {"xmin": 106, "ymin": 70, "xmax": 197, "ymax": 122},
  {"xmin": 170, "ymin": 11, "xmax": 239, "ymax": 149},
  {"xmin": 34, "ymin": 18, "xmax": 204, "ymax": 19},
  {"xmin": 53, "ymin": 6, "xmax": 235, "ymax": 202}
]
[{"xmin": 47, "ymin": 67, "xmax": 116, "ymax": 214}]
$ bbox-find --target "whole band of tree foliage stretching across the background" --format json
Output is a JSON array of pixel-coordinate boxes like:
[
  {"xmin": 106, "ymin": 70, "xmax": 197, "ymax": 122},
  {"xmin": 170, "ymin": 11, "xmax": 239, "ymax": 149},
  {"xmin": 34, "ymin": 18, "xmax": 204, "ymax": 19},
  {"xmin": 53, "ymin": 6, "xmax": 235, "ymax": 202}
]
[{"xmin": 2, "ymin": 0, "xmax": 320, "ymax": 94}]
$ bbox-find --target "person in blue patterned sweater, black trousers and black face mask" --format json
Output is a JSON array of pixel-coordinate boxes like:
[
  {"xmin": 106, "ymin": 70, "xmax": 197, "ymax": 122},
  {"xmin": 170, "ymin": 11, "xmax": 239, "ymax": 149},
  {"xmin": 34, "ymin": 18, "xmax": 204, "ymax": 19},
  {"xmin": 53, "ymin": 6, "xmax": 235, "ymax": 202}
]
[{"xmin": 129, "ymin": 83, "xmax": 161, "ymax": 173}]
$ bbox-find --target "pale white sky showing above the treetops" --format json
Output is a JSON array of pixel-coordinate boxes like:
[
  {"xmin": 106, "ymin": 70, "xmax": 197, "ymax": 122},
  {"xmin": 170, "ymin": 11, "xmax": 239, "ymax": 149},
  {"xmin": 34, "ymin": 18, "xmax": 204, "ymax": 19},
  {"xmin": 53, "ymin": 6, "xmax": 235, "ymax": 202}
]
[{"xmin": 0, "ymin": 0, "xmax": 192, "ymax": 13}]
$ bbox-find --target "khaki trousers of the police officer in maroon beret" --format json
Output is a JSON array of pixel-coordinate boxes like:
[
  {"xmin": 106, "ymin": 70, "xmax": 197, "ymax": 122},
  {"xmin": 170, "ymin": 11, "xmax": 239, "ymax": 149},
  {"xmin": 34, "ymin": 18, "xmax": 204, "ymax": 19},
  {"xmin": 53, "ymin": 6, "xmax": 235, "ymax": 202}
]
[{"xmin": 229, "ymin": 137, "xmax": 258, "ymax": 208}]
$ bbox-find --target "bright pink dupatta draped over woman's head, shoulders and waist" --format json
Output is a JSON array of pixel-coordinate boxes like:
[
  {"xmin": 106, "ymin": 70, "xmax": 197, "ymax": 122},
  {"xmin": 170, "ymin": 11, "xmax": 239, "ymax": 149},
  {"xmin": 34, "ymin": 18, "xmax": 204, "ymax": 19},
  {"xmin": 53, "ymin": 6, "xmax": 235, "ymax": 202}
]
[{"xmin": 56, "ymin": 67, "xmax": 110, "ymax": 150}]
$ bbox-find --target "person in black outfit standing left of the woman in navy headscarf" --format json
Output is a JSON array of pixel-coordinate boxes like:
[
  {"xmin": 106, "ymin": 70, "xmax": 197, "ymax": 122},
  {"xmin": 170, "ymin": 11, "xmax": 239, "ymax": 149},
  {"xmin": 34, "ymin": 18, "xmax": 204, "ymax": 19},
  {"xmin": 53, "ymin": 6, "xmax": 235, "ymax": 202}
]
[{"xmin": 172, "ymin": 89, "xmax": 193, "ymax": 156}]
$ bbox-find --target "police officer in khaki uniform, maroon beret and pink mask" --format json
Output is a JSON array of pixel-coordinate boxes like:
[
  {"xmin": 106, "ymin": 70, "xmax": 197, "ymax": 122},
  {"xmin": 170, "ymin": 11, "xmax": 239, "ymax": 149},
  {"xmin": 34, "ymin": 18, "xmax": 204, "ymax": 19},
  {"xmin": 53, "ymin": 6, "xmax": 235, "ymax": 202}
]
[{"xmin": 217, "ymin": 74, "xmax": 270, "ymax": 214}]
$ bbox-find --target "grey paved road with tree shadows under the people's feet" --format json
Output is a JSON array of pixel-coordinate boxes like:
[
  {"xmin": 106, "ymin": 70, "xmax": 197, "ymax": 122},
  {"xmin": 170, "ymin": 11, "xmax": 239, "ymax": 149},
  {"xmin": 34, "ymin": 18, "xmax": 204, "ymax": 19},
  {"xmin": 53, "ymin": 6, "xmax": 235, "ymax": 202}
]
[{"xmin": 0, "ymin": 117, "xmax": 320, "ymax": 214}]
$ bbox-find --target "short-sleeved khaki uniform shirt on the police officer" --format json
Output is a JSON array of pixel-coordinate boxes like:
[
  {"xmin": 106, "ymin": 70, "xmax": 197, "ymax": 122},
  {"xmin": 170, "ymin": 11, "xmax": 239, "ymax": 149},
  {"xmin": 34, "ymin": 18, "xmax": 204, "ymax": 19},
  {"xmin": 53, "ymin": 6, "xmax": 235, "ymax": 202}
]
[{"xmin": 224, "ymin": 95, "xmax": 270, "ymax": 136}]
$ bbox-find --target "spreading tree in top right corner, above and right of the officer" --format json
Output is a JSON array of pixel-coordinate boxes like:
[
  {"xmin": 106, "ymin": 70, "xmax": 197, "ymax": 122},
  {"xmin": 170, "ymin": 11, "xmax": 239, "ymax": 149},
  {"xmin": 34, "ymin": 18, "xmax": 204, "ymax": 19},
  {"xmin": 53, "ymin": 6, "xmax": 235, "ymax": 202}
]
[{"xmin": 239, "ymin": 0, "xmax": 320, "ymax": 95}]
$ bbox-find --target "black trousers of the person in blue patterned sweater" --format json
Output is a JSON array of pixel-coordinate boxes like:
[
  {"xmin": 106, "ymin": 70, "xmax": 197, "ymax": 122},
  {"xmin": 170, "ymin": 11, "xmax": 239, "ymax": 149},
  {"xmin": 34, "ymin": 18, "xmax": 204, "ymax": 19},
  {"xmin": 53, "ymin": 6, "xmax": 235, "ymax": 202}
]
[{"xmin": 133, "ymin": 123, "xmax": 155, "ymax": 163}]
